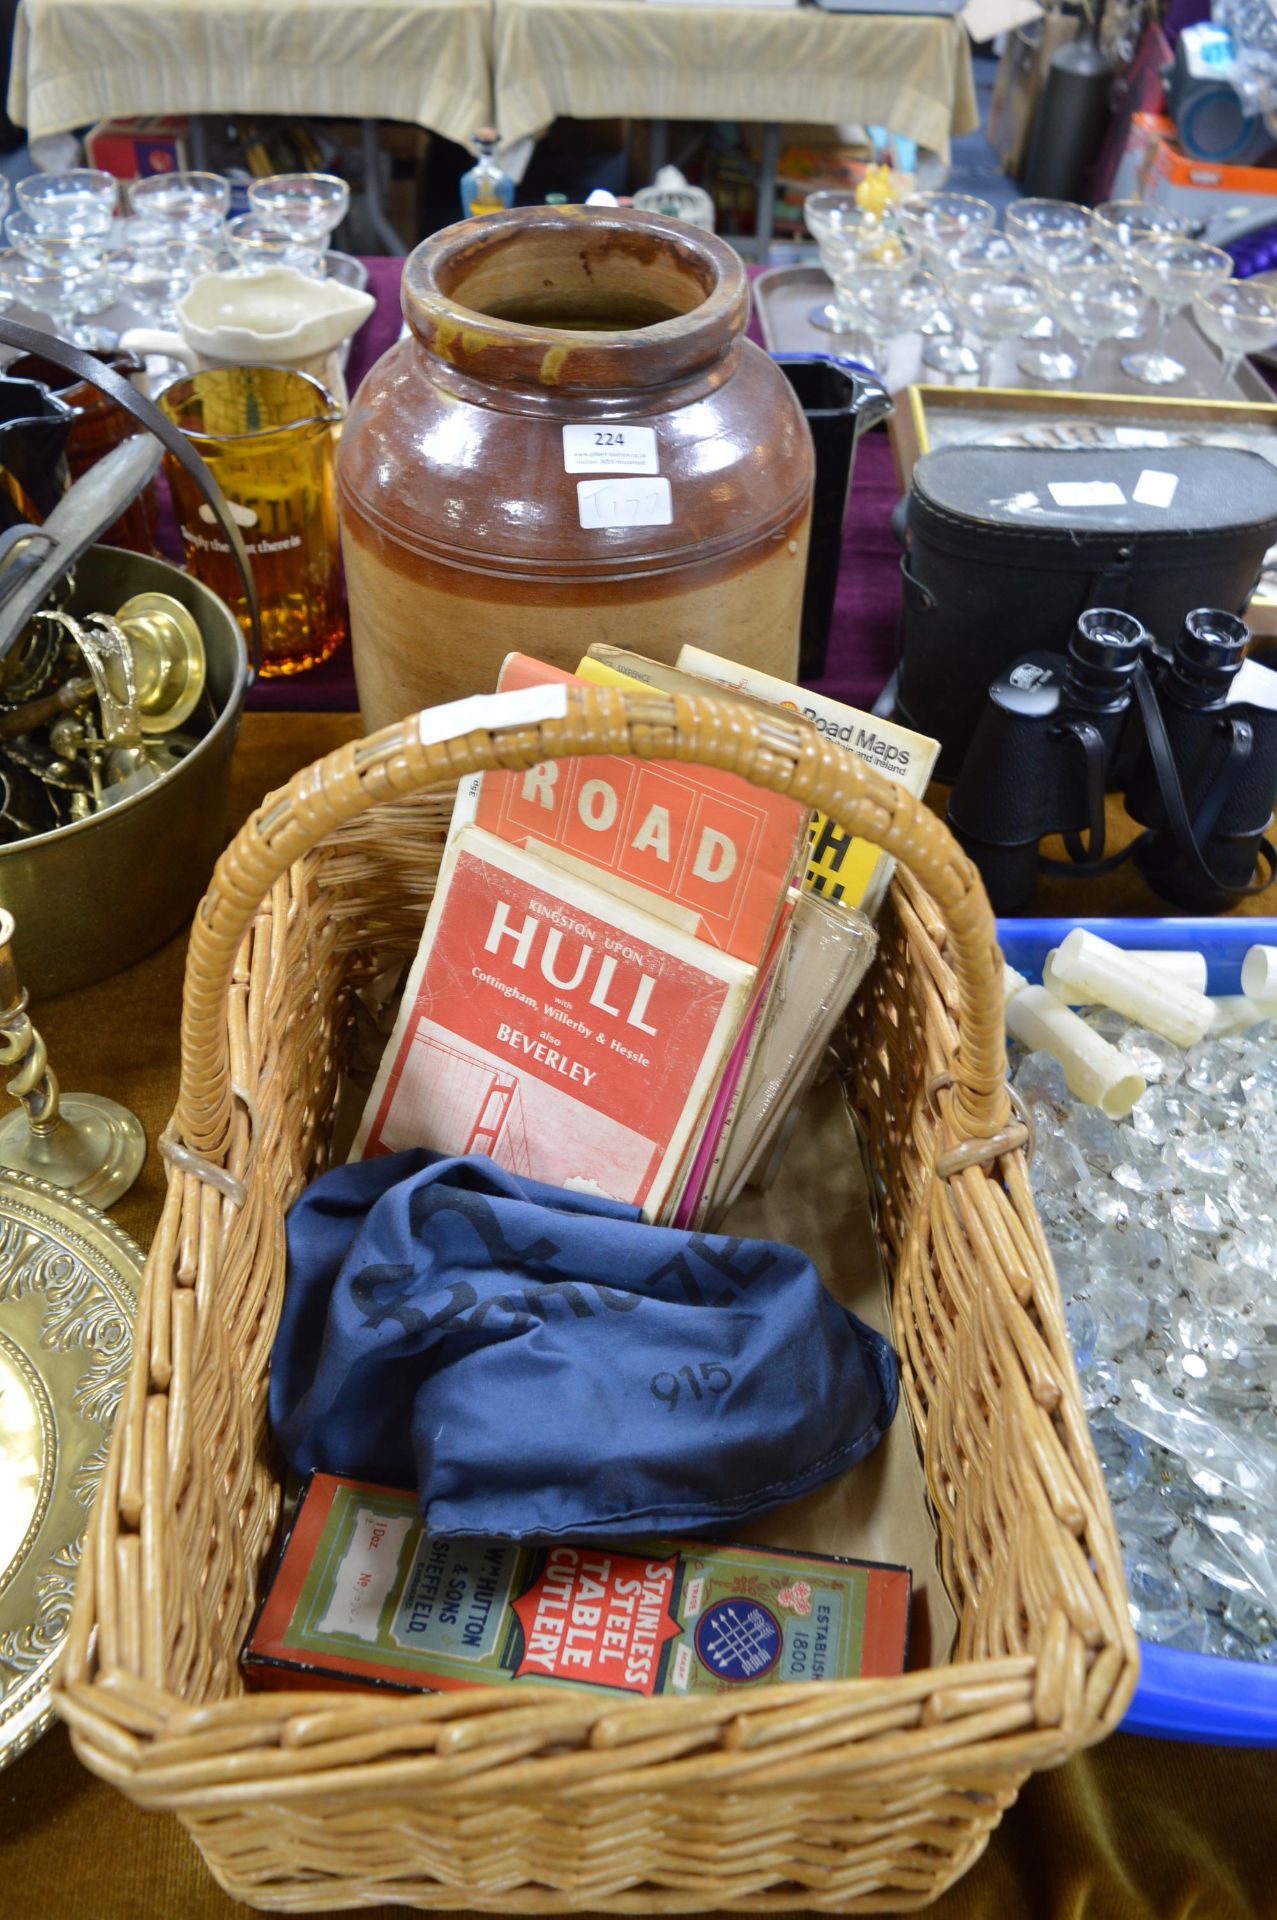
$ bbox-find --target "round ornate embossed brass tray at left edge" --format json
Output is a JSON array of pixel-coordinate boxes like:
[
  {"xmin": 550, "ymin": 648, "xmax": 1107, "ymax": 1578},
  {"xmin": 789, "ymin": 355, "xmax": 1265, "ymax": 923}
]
[{"xmin": 0, "ymin": 1169, "xmax": 142, "ymax": 1766}]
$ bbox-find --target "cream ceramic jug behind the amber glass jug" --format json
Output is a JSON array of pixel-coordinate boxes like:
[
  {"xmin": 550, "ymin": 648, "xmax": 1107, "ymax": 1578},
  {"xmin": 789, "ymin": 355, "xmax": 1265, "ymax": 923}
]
[{"xmin": 119, "ymin": 267, "xmax": 376, "ymax": 411}]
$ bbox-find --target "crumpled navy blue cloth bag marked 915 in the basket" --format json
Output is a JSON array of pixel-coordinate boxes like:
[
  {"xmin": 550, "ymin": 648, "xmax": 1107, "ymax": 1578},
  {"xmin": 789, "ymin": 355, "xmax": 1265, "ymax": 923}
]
[{"xmin": 271, "ymin": 1150, "xmax": 899, "ymax": 1540}]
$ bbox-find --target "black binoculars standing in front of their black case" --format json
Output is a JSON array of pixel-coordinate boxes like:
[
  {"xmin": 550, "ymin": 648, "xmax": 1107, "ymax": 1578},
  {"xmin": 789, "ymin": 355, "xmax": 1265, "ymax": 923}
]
[{"xmin": 949, "ymin": 607, "xmax": 1277, "ymax": 914}]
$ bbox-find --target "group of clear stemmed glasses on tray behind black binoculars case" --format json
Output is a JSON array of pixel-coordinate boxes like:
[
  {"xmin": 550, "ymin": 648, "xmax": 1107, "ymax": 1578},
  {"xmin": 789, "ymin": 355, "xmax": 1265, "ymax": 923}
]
[{"xmin": 803, "ymin": 190, "xmax": 1277, "ymax": 390}]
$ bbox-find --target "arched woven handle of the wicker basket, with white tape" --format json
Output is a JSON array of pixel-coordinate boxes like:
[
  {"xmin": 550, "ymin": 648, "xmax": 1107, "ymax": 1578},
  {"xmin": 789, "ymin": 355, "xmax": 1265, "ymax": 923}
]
[{"xmin": 169, "ymin": 685, "xmax": 1010, "ymax": 1181}]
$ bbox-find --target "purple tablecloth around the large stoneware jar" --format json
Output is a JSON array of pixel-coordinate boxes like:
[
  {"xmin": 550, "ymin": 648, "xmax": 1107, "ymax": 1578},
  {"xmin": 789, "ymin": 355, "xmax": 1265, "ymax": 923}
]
[{"xmin": 248, "ymin": 259, "xmax": 901, "ymax": 712}]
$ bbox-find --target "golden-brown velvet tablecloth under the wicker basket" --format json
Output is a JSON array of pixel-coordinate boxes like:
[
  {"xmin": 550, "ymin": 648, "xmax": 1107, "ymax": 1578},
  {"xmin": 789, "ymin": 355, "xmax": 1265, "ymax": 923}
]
[{"xmin": 0, "ymin": 712, "xmax": 1277, "ymax": 1920}]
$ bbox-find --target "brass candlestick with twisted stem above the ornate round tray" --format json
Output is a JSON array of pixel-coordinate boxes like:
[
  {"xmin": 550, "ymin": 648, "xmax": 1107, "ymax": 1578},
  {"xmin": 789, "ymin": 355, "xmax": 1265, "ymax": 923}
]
[{"xmin": 0, "ymin": 908, "xmax": 146, "ymax": 1208}]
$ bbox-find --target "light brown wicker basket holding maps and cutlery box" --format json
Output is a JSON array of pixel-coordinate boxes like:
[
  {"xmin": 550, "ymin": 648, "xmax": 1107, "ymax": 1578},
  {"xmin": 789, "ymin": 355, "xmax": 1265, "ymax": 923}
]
[{"xmin": 58, "ymin": 689, "xmax": 1137, "ymax": 1912}]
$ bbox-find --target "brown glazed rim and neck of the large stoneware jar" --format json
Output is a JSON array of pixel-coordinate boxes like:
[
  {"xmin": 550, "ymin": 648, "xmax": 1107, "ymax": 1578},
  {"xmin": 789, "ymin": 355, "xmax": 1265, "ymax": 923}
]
[{"xmin": 403, "ymin": 207, "xmax": 749, "ymax": 407}]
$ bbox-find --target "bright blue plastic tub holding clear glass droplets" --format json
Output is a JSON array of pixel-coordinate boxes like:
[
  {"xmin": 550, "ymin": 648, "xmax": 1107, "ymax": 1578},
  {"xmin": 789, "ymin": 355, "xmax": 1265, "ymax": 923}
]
[{"xmin": 999, "ymin": 918, "xmax": 1277, "ymax": 1747}]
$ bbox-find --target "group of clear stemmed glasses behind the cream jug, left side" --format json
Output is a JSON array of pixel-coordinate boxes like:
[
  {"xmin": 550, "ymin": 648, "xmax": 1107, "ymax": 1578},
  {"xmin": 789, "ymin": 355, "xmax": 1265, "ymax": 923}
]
[{"xmin": 0, "ymin": 167, "xmax": 359, "ymax": 351}]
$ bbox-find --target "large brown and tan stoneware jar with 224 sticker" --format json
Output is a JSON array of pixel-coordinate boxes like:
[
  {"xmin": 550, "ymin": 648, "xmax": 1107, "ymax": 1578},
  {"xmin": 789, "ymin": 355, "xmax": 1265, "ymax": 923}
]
[{"xmin": 338, "ymin": 207, "xmax": 812, "ymax": 728}]
